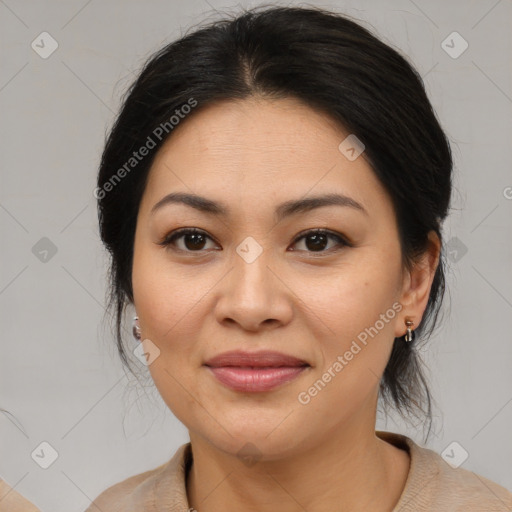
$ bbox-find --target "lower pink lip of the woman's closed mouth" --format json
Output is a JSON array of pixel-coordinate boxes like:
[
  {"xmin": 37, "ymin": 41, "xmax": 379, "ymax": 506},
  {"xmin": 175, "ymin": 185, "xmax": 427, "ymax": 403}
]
[{"xmin": 207, "ymin": 366, "xmax": 308, "ymax": 393}]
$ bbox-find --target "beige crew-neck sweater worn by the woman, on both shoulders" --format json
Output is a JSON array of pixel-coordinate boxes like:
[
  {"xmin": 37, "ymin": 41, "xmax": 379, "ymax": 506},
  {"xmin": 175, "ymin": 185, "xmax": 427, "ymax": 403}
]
[{"xmin": 85, "ymin": 431, "xmax": 512, "ymax": 512}]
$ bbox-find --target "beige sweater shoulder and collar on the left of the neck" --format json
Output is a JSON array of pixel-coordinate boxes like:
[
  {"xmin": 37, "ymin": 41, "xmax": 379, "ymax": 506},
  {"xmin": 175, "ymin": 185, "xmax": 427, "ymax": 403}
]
[{"xmin": 85, "ymin": 443, "xmax": 190, "ymax": 512}]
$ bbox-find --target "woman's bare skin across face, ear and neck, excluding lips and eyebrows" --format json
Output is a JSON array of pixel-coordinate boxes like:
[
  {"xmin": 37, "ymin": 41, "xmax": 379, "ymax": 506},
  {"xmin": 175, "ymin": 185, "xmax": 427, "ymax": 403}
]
[{"xmin": 132, "ymin": 98, "xmax": 439, "ymax": 512}]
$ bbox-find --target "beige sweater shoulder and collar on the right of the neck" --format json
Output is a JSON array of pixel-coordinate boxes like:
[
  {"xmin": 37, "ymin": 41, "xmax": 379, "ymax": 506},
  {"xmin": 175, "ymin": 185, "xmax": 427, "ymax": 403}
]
[{"xmin": 378, "ymin": 432, "xmax": 512, "ymax": 512}]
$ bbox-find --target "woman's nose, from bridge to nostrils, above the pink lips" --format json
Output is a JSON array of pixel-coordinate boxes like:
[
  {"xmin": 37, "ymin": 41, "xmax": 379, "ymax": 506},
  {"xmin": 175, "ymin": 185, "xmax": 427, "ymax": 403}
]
[{"xmin": 215, "ymin": 247, "xmax": 293, "ymax": 332}]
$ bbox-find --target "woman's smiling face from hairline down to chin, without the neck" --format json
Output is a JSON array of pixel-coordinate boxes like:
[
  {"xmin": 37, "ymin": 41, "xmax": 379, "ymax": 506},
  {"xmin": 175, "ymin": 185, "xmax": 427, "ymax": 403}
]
[{"xmin": 132, "ymin": 99, "xmax": 430, "ymax": 459}]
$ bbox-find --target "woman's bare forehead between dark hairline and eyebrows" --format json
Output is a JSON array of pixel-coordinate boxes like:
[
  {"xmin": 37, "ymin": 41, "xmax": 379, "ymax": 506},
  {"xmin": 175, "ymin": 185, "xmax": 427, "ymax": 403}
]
[{"xmin": 140, "ymin": 98, "xmax": 390, "ymax": 221}]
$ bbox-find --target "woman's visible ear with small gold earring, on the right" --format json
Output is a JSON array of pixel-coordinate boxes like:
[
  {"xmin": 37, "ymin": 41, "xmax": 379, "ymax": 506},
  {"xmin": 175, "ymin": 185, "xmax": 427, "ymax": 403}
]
[{"xmin": 395, "ymin": 231, "xmax": 441, "ymax": 338}]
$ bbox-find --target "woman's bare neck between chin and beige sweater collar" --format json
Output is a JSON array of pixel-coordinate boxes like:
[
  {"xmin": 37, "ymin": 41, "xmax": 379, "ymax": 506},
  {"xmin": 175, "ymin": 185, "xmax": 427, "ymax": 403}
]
[{"xmin": 187, "ymin": 420, "xmax": 409, "ymax": 512}]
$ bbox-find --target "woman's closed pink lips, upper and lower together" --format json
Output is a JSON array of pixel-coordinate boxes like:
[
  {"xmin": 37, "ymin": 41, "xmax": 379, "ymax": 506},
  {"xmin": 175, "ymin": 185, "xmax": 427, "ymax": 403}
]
[{"xmin": 205, "ymin": 351, "xmax": 309, "ymax": 392}]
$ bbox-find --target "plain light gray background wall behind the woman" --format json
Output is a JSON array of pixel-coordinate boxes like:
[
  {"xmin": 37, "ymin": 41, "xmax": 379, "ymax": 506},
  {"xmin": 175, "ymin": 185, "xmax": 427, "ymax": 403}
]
[{"xmin": 0, "ymin": 0, "xmax": 512, "ymax": 512}]
